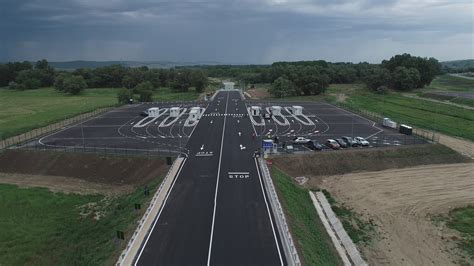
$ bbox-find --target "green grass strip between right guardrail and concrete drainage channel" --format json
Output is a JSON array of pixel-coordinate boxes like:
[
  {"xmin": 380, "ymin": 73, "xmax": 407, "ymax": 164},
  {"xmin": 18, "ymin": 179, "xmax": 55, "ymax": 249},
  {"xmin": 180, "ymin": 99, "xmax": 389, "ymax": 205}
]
[{"xmin": 271, "ymin": 167, "xmax": 341, "ymax": 265}]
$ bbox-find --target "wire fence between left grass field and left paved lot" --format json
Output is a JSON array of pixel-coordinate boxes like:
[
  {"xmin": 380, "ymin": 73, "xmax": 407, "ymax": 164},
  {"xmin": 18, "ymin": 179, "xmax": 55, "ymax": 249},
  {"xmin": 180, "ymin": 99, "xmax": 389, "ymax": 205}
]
[{"xmin": 0, "ymin": 107, "xmax": 114, "ymax": 150}]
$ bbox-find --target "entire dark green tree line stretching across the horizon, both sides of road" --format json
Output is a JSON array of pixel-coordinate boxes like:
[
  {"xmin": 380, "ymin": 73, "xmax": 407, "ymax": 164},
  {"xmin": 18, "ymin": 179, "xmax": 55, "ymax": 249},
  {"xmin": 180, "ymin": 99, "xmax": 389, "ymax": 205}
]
[{"xmin": 0, "ymin": 54, "xmax": 441, "ymax": 101}]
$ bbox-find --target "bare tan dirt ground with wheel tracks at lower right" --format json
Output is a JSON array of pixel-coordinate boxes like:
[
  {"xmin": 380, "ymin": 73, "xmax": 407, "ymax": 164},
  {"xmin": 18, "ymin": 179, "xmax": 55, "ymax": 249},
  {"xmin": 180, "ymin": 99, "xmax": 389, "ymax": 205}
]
[{"xmin": 321, "ymin": 163, "xmax": 474, "ymax": 265}]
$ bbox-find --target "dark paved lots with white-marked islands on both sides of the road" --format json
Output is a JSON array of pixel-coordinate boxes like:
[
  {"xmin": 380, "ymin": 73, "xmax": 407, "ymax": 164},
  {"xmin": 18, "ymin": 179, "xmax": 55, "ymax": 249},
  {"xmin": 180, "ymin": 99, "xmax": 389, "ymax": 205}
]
[{"xmin": 29, "ymin": 102, "xmax": 424, "ymax": 154}]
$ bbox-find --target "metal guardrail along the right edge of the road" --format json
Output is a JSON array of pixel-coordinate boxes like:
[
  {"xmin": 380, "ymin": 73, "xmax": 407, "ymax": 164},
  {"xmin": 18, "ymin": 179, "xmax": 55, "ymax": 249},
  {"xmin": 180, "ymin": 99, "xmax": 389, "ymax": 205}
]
[{"xmin": 258, "ymin": 158, "xmax": 301, "ymax": 266}]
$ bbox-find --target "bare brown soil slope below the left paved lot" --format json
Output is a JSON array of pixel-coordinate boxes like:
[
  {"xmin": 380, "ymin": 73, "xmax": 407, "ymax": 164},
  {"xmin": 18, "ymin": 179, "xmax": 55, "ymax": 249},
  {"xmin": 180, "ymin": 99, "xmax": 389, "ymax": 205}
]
[{"xmin": 0, "ymin": 150, "xmax": 169, "ymax": 186}]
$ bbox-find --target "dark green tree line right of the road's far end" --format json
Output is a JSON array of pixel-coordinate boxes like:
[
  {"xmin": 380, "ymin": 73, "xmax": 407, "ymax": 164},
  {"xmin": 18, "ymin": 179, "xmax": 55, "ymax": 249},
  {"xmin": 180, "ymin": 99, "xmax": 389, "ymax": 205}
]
[{"xmin": 196, "ymin": 54, "xmax": 441, "ymax": 97}]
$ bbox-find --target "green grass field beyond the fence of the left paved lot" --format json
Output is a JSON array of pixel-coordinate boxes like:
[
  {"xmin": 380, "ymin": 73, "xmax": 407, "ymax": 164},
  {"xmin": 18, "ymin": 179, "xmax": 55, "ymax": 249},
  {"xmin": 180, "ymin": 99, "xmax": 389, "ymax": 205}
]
[{"xmin": 0, "ymin": 88, "xmax": 198, "ymax": 139}]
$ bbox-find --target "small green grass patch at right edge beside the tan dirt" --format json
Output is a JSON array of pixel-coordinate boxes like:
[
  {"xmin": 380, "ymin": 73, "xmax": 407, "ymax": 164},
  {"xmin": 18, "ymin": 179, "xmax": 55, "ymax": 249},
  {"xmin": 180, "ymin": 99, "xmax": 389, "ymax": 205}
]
[{"xmin": 447, "ymin": 206, "xmax": 474, "ymax": 260}]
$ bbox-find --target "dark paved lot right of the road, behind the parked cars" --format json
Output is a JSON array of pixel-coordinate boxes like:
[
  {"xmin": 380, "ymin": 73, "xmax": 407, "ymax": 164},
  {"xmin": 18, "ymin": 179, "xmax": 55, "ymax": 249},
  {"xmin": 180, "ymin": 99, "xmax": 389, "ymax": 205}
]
[{"xmin": 247, "ymin": 102, "xmax": 425, "ymax": 150}]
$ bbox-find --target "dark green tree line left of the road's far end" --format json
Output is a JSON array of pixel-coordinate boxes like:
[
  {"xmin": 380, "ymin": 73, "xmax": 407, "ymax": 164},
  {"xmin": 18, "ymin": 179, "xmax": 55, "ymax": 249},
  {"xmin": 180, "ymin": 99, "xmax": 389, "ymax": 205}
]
[{"xmin": 0, "ymin": 59, "xmax": 207, "ymax": 98}]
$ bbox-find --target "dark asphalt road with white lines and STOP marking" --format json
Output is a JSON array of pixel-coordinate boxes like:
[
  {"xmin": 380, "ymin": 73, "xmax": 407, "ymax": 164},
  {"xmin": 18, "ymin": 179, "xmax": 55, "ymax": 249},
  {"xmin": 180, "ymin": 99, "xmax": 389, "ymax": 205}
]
[{"xmin": 136, "ymin": 91, "xmax": 285, "ymax": 265}]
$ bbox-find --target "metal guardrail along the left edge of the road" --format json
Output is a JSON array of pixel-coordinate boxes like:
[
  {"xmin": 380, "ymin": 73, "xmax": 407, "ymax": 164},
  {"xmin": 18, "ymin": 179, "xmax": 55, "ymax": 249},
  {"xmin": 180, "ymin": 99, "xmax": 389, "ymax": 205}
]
[{"xmin": 116, "ymin": 157, "xmax": 184, "ymax": 266}]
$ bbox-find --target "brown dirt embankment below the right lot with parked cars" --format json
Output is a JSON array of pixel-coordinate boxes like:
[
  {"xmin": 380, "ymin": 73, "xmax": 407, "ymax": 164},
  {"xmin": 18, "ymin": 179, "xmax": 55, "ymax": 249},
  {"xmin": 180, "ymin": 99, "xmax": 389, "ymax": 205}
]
[{"xmin": 272, "ymin": 144, "xmax": 471, "ymax": 185}]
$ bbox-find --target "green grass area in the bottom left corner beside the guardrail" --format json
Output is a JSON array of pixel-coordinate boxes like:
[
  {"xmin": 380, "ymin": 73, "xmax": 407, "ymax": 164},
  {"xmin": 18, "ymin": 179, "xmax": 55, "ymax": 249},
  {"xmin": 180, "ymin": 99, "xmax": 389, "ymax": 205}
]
[{"xmin": 0, "ymin": 178, "xmax": 159, "ymax": 265}]
